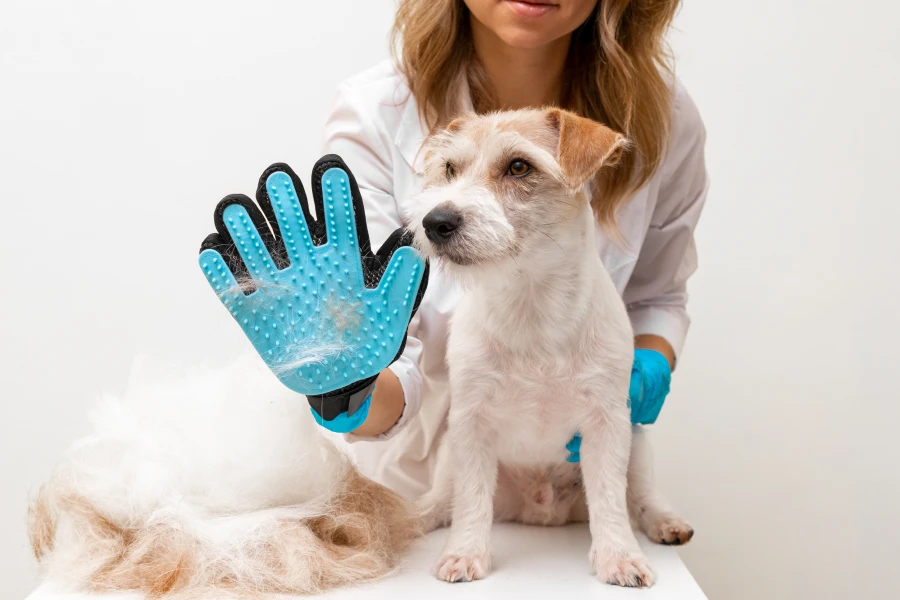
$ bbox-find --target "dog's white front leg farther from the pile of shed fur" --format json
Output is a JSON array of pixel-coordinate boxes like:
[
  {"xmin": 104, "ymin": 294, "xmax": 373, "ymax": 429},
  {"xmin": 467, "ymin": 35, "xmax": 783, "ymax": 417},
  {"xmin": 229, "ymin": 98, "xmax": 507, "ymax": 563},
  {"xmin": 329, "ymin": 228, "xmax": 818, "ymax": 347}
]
[{"xmin": 581, "ymin": 404, "xmax": 653, "ymax": 587}]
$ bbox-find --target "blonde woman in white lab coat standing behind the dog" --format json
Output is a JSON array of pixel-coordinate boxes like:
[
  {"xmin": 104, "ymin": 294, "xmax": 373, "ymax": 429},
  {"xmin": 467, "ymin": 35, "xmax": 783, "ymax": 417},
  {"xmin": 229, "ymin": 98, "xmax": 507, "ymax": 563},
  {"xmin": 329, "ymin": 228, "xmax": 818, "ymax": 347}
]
[{"xmin": 325, "ymin": 0, "xmax": 707, "ymax": 506}]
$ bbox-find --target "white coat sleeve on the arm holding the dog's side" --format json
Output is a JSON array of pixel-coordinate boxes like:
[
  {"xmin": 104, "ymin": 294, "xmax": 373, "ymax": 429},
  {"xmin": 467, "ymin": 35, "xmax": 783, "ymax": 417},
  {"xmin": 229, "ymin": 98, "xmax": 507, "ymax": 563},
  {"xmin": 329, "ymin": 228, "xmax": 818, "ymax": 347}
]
[{"xmin": 623, "ymin": 84, "xmax": 708, "ymax": 364}]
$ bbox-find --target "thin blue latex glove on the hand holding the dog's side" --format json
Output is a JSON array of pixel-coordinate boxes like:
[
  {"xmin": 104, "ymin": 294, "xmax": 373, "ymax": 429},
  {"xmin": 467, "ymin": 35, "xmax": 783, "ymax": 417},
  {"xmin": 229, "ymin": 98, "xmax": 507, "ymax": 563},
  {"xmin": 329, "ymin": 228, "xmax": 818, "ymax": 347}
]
[{"xmin": 566, "ymin": 348, "xmax": 672, "ymax": 462}]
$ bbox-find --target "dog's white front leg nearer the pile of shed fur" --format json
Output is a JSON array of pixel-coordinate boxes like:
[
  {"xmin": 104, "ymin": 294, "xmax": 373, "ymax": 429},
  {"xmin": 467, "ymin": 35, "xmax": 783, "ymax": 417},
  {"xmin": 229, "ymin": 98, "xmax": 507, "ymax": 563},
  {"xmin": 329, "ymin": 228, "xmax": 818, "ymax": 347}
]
[{"xmin": 435, "ymin": 404, "xmax": 497, "ymax": 582}]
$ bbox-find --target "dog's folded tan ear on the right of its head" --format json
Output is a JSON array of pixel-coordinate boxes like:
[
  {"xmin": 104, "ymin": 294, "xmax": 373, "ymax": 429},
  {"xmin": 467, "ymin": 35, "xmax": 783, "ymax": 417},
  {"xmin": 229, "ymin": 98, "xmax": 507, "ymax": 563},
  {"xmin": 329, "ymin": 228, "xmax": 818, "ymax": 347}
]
[{"xmin": 547, "ymin": 108, "xmax": 628, "ymax": 189}]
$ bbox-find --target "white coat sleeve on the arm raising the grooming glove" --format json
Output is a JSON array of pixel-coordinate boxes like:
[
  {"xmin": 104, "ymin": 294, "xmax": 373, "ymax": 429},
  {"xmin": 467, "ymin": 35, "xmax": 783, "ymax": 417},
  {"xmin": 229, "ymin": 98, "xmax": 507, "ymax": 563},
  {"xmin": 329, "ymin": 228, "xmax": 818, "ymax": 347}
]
[{"xmin": 324, "ymin": 85, "xmax": 422, "ymax": 440}]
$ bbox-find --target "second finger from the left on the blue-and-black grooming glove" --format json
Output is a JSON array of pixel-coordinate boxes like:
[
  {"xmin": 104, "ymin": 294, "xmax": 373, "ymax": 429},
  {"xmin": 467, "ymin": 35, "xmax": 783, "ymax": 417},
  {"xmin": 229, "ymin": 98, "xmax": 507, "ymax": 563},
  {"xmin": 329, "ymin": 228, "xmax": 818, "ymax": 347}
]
[{"xmin": 216, "ymin": 194, "xmax": 278, "ymax": 287}]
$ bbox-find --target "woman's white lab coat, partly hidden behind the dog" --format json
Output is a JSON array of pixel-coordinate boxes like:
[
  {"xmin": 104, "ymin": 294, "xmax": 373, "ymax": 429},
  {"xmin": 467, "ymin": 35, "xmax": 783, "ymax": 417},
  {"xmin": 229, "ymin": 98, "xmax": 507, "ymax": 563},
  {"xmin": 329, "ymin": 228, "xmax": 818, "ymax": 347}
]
[{"xmin": 324, "ymin": 61, "xmax": 707, "ymax": 498}]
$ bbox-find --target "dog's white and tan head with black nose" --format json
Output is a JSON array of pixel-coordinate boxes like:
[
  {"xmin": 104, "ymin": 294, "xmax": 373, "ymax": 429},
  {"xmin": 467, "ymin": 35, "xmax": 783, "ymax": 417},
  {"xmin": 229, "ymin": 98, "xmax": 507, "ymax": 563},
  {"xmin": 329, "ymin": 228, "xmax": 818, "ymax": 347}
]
[{"xmin": 410, "ymin": 108, "xmax": 626, "ymax": 274}]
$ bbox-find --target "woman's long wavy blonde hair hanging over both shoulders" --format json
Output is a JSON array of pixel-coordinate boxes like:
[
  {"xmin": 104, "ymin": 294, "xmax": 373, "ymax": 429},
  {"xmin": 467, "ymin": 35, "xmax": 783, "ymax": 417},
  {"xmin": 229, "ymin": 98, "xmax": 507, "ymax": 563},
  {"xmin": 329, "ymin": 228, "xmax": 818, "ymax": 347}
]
[{"xmin": 392, "ymin": 0, "xmax": 679, "ymax": 223}]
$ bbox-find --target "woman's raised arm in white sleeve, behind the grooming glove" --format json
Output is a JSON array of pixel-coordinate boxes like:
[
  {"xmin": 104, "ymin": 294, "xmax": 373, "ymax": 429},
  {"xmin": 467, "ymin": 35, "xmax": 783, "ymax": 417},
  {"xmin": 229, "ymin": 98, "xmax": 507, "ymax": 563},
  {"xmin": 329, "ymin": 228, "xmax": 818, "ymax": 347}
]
[{"xmin": 324, "ymin": 85, "xmax": 422, "ymax": 437}]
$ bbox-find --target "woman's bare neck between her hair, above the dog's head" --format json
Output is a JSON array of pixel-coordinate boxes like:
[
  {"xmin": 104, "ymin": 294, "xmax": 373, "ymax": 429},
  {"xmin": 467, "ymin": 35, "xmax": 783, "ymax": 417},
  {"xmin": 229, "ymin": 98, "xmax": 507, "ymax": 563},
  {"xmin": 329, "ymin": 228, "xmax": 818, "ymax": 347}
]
[{"xmin": 470, "ymin": 16, "xmax": 571, "ymax": 110}]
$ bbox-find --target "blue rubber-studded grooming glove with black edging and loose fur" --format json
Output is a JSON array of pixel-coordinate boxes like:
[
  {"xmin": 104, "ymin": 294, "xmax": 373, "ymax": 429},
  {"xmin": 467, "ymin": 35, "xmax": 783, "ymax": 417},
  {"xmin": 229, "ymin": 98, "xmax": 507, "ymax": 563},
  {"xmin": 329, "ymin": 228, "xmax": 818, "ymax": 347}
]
[{"xmin": 200, "ymin": 155, "xmax": 428, "ymax": 433}]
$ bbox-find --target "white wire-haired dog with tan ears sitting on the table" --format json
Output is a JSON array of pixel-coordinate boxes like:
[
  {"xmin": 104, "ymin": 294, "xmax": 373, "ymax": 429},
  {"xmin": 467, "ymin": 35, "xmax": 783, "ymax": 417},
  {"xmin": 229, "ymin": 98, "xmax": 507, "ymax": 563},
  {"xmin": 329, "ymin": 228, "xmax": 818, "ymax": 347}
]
[{"xmin": 409, "ymin": 108, "xmax": 693, "ymax": 587}]
